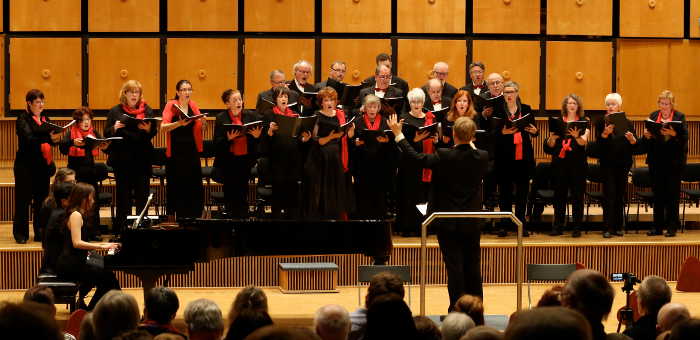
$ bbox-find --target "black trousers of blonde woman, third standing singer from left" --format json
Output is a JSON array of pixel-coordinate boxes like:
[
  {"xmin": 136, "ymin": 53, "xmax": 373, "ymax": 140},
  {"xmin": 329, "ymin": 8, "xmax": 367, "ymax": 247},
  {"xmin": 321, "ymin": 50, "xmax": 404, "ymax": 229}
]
[{"xmin": 113, "ymin": 165, "xmax": 151, "ymax": 232}]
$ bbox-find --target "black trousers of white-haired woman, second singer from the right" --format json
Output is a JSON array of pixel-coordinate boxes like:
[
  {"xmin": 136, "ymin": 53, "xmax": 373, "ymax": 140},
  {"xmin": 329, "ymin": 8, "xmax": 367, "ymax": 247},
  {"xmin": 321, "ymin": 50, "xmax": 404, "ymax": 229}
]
[{"xmin": 600, "ymin": 164, "xmax": 629, "ymax": 232}]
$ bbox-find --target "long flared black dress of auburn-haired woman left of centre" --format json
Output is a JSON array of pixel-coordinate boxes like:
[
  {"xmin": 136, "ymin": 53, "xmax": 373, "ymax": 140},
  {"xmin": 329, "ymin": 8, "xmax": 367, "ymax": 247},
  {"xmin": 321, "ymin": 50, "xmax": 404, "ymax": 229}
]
[{"xmin": 304, "ymin": 112, "xmax": 354, "ymax": 219}]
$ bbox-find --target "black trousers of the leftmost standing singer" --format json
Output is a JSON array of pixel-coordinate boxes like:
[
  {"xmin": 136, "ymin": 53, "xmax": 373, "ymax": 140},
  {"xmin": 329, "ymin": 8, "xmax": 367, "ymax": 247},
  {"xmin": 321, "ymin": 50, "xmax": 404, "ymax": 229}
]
[{"xmin": 12, "ymin": 161, "xmax": 51, "ymax": 241}]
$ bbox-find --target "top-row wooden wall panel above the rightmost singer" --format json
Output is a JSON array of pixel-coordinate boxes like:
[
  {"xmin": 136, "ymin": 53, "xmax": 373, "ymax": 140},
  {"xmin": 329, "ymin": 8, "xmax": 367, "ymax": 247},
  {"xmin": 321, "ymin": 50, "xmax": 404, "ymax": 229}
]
[{"xmin": 620, "ymin": 0, "xmax": 684, "ymax": 38}]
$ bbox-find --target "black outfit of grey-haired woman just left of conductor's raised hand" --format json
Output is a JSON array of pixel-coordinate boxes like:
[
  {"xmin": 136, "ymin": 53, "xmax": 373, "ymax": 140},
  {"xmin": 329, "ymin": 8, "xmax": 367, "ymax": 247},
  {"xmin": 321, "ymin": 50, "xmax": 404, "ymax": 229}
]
[{"xmin": 351, "ymin": 116, "xmax": 398, "ymax": 219}]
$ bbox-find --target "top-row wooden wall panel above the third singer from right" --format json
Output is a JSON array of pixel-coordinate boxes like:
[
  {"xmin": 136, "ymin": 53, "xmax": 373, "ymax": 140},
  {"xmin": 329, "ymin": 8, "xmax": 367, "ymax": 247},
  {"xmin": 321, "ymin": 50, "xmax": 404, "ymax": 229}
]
[{"xmin": 547, "ymin": 0, "xmax": 613, "ymax": 35}]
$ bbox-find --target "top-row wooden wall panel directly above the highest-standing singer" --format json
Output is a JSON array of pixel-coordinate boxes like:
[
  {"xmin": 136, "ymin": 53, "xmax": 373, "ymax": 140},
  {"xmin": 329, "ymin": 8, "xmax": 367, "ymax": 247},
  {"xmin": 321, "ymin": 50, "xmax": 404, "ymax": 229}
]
[{"xmin": 322, "ymin": 0, "xmax": 391, "ymax": 33}]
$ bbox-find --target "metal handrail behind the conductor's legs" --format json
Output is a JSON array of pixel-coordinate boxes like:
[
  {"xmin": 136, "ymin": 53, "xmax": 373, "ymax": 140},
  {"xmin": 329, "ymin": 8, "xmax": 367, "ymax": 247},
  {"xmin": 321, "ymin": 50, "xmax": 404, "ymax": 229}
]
[{"xmin": 420, "ymin": 211, "xmax": 524, "ymax": 316}]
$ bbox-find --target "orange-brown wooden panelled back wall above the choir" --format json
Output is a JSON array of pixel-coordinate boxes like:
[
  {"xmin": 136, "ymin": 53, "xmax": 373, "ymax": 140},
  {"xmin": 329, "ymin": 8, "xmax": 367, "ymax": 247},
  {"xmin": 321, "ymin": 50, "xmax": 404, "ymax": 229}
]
[{"xmin": 0, "ymin": 0, "xmax": 700, "ymax": 120}]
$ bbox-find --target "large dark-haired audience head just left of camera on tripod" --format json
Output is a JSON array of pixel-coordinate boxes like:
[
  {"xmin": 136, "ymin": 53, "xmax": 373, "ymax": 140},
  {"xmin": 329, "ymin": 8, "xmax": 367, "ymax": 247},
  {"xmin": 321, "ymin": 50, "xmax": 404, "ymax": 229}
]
[{"xmin": 560, "ymin": 269, "xmax": 615, "ymax": 340}]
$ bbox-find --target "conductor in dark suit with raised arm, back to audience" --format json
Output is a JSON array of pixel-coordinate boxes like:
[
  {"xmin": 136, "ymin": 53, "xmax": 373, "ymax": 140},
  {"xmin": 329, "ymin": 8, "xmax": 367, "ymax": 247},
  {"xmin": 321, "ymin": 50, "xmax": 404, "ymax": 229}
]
[{"xmin": 388, "ymin": 115, "xmax": 489, "ymax": 311}]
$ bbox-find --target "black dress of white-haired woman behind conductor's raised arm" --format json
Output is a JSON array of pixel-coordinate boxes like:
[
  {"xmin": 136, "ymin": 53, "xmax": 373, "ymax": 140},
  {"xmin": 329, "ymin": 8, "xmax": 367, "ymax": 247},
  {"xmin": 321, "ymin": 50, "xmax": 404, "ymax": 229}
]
[{"xmin": 395, "ymin": 113, "xmax": 431, "ymax": 236}]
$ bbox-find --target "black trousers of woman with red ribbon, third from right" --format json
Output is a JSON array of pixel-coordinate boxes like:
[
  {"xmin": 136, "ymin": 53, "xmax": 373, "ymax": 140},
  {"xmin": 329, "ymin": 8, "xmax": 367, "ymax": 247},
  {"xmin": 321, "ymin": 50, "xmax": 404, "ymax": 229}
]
[{"xmin": 553, "ymin": 164, "xmax": 586, "ymax": 228}]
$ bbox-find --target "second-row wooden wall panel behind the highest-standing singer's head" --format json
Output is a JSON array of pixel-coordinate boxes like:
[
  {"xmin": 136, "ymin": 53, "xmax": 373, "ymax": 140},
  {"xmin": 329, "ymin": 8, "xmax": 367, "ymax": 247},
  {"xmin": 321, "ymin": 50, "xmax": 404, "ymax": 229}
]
[{"xmin": 318, "ymin": 39, "xmax": 391, "ymax": 84}]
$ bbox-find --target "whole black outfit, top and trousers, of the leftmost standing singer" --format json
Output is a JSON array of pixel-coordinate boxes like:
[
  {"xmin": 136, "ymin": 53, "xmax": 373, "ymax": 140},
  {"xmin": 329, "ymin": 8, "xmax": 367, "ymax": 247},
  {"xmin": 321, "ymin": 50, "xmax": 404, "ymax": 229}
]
[{"xmin": 12, "ymin": 112, "xmax": 56, "ymax": 242}]
